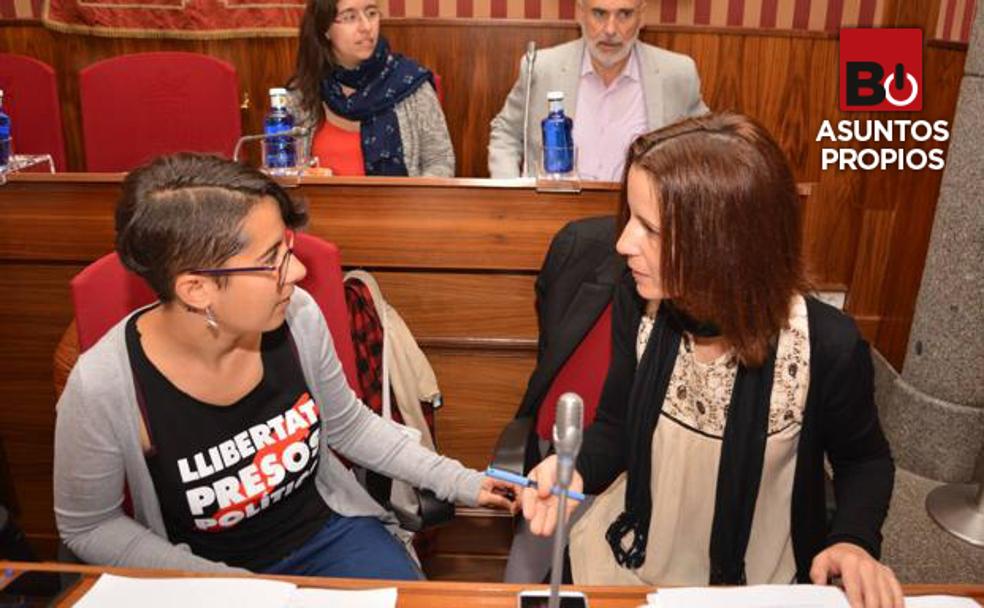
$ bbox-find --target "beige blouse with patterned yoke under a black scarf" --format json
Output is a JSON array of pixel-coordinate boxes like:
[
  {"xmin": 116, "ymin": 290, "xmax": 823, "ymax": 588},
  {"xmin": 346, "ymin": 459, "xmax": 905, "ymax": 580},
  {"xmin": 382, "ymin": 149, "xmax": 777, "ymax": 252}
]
[{"xmin": 571, "ymin": 296, "xmax": 810, "ymax": 585}]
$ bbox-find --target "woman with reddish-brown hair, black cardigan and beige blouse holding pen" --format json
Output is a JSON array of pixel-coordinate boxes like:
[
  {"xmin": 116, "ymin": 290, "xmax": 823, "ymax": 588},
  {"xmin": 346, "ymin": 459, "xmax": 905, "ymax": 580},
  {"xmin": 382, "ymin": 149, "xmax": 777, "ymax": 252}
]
[{"xmin": 523, "ymin": 114, "xmax": 902, "ymax": 607}]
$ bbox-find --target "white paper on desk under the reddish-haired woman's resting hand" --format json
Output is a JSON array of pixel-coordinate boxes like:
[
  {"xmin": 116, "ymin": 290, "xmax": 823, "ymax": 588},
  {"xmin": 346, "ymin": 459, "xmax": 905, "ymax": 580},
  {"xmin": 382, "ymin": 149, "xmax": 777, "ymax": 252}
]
[{"xmin": 646, "ymin": 585, "xmax": 850, "ymax": 608}]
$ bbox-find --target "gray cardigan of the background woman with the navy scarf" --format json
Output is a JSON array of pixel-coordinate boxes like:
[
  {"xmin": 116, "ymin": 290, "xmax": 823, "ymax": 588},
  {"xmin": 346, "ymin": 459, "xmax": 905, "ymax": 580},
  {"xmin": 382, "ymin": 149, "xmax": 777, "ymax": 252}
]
[{"xmin": 288, "ymin": 83, "xmax": 454, "ymax": 177}]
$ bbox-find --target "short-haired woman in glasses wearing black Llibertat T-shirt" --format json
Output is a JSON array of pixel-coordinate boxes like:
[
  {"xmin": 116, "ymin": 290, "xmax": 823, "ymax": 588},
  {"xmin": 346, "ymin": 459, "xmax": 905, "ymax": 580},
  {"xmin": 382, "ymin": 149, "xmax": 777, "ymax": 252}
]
[{"xmin": 54, "ymin": 154, "xmax": 510, "ymax": 579}]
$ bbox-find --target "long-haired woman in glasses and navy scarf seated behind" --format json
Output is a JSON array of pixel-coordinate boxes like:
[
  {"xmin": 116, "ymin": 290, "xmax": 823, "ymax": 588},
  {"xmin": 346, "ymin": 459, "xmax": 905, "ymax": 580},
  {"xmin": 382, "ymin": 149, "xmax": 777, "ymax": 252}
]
[{"xmin": 288, "ymin": 0, "xmax": 454, "ymax": 177}]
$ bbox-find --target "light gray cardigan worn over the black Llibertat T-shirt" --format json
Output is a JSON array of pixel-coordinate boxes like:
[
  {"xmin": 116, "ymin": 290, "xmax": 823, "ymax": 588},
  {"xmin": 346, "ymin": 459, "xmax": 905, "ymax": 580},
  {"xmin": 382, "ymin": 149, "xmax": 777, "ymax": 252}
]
[{"xmin": 54, "ymin": 289, "xmax": 482, "ymax": 572}]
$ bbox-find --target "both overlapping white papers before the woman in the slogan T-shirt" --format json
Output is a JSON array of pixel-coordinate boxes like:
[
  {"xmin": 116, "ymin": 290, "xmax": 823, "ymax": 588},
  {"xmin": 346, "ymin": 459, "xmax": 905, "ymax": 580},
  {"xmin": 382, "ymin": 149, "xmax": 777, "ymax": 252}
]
[{"xmin": 75, "ymin": 574, "xmax": 396, "ymax": 608}]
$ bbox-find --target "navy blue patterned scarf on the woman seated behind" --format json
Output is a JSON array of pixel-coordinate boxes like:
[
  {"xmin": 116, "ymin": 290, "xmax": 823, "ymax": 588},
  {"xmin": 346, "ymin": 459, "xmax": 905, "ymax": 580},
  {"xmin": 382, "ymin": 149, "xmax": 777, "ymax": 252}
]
[{"xmin": 321, "ymin": 36, "xmax": 434, "ymax": 175}]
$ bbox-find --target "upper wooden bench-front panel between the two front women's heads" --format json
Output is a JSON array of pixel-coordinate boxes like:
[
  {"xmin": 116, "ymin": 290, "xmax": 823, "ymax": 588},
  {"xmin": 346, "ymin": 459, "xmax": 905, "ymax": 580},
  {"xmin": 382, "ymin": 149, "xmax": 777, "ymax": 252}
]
[{"xmin": 299, "ymin": 180, "xmax": 617, "ymax": 271}]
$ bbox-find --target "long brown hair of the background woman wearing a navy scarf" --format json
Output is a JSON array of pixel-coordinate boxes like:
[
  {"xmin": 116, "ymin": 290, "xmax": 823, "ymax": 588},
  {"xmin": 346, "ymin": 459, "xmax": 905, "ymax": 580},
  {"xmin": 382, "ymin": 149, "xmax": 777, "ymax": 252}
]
[{"xmin": 287, "ymin": 0, "xmax": 338, "ymax": 124}]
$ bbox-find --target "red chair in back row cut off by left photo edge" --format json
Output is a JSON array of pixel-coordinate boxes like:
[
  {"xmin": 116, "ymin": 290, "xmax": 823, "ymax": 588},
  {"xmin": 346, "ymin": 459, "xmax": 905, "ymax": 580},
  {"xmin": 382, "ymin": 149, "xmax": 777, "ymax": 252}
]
[{"xmin": 0, "ymin": 53, "xmax": 68, "ymax": 171}]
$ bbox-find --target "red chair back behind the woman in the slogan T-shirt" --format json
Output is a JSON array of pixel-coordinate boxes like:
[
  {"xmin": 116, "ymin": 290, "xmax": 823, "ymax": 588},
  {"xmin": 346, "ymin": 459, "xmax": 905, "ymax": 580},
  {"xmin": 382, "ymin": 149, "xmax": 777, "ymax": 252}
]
[{"xmin": 71, "ymin": 233, "xmax": 359, "ymax": 393}]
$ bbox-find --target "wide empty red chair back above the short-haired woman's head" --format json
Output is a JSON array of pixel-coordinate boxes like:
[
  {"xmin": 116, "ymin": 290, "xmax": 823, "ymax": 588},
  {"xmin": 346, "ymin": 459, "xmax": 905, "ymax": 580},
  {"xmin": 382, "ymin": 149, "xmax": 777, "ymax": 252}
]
[{"xmin": 79, "ymin": 52, "xmax": 241, "ymax": 171}]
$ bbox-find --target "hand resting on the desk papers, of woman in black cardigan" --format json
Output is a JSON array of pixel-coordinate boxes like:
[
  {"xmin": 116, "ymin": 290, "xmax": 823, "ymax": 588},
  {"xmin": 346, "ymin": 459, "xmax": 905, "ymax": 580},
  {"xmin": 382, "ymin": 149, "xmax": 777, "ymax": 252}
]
[{"xmin": 810, "ymin": 543, "xmax": 904, "ymax": 608}]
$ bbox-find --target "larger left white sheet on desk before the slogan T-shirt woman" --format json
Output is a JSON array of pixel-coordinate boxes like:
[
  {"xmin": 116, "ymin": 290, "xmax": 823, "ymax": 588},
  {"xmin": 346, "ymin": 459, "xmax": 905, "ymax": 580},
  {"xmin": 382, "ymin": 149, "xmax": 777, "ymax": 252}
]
[{"xmin": 75, "ymin": 574, "xmax": 297, "ymax": 608}]
